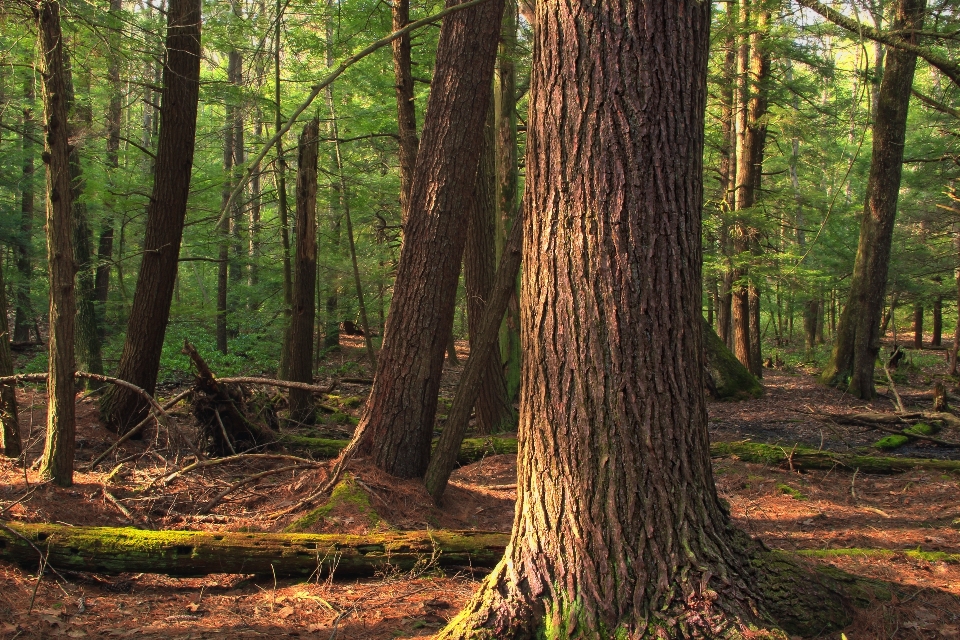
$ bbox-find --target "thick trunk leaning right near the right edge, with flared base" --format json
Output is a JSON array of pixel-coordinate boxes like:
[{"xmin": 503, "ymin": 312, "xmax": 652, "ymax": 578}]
[{"xmin": 822, "ymin": 0, "xmax": 926, "ymax": 400}]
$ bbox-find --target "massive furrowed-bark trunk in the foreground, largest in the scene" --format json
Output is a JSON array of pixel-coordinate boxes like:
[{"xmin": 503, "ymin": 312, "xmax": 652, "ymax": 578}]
[{"xmin": 438, "ymin": 0, "xmax": 848, "ymax": 639}]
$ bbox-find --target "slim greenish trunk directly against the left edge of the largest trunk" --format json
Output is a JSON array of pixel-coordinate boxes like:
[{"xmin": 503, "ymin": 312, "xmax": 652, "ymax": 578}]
[{"xmin": 494, "ymin": 0, "xmax": 522, "ymax": 403}]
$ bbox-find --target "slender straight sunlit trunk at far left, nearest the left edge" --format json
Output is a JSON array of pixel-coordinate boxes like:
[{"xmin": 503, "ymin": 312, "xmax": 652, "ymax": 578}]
[{"xmin": 35, "ymin": 0, "xmax": 77, "ymax": 487}]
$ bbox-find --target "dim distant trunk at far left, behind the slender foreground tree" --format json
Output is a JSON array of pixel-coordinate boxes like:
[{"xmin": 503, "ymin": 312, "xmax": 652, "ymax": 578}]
[{"xmin": 13, "ymin": 75, "xmax": 40, "ymax": 342}]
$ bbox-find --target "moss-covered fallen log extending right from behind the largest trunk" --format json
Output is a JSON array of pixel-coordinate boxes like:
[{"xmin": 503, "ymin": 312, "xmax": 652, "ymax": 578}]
[{"xmin": 710, "ymin": 442, "xmax": 960, "ymax": 474}]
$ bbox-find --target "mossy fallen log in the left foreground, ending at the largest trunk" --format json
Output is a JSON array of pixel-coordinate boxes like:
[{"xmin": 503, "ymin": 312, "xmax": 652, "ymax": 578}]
[{"xmin": 0, "ymin": 522, "xmax": 510, "ymax": 577}]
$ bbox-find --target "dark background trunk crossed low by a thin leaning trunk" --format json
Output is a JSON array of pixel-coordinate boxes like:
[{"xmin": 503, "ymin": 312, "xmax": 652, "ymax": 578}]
[{"xmin": 463, "ymin": 101, "xmax": 516, "ymax": 434}]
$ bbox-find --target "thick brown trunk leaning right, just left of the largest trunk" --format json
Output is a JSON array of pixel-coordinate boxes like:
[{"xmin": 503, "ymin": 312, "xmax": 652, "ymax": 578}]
[{"xmin": 350, "ymin": 0, "xmax": 503, "ymax": 477}]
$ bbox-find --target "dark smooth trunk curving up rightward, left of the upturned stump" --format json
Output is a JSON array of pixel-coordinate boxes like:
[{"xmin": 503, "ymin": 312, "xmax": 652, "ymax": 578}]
[{"xmin": 100, "ymin": 0, "xmax": 201, "ymax": 432}]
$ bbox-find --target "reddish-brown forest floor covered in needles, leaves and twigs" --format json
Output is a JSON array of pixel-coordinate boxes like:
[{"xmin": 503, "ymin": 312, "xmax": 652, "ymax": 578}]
[{"xmin": 0, "ymin": 339, "xmax": 960, "ymax": 640}]
